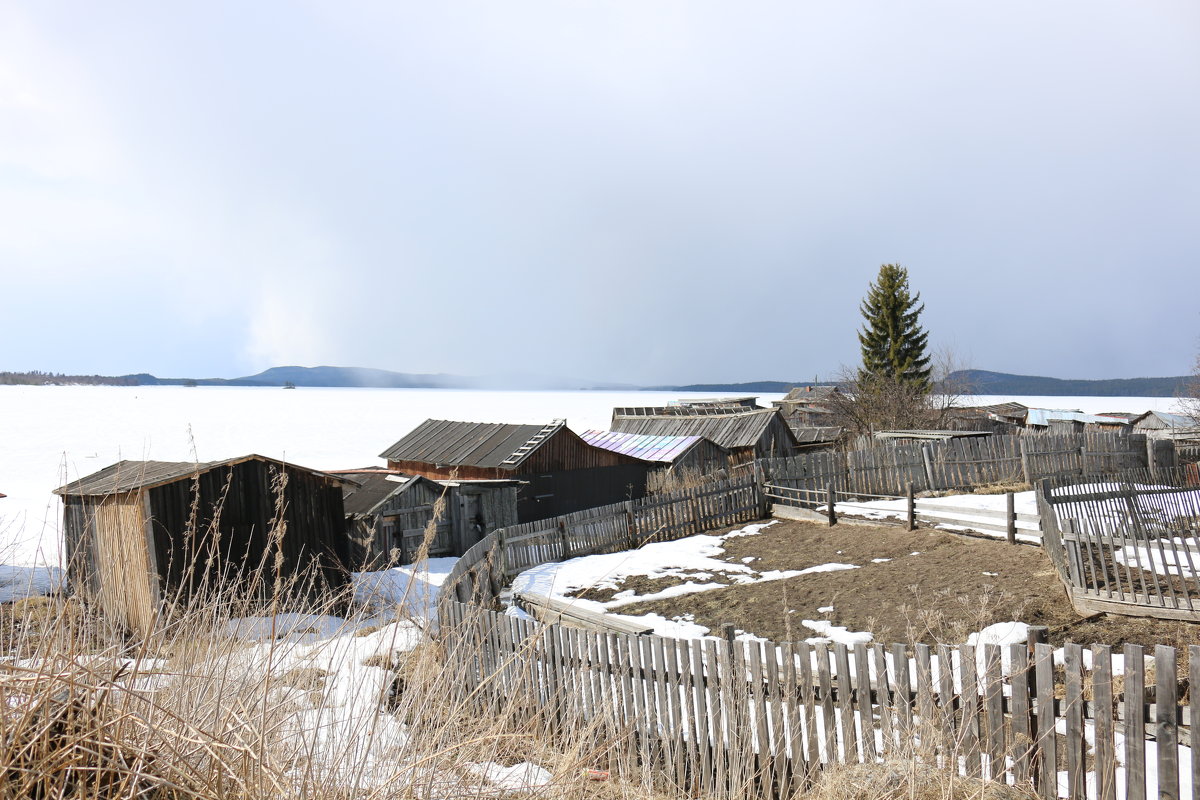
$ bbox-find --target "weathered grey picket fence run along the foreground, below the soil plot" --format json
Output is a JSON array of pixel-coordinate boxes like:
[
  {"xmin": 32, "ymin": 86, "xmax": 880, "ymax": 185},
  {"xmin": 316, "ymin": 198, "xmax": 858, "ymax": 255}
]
[{"xmin": 443, "ymin": 603, "xmax": 1200, "ymax": 800}]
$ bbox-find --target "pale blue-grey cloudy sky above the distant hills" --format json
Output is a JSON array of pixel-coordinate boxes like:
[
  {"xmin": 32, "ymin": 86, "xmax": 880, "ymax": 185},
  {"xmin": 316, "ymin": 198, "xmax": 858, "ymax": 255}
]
[{"xmin": 0, "ymin": 0, "xmax": 1200, "ymax": 384}]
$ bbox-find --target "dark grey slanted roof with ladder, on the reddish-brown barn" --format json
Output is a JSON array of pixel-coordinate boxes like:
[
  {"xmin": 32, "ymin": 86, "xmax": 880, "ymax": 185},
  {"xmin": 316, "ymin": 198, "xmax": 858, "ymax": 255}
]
[{"xmin": 379, "ymin": 420, "xmax": 566, "ymax": 469}]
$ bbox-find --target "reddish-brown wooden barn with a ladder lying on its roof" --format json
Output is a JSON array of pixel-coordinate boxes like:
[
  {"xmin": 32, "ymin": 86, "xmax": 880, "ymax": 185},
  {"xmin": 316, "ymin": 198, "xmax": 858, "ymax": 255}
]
[{"xmin": 380, "ymin": 420, "xmax": 653, "ymax": 522}]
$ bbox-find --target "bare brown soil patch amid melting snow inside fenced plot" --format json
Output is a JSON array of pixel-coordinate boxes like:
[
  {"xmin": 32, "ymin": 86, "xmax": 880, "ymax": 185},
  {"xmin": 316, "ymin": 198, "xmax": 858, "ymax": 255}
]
[{"xmin": 609, "ymin": 521, "xmax": 1200, "ymax": 646}]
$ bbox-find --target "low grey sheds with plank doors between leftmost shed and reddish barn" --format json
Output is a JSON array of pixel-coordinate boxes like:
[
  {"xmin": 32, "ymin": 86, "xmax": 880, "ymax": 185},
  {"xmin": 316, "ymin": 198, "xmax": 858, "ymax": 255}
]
[{"xmin": 335, "ymin": 468, "xmax": 521, "ymax": 570}]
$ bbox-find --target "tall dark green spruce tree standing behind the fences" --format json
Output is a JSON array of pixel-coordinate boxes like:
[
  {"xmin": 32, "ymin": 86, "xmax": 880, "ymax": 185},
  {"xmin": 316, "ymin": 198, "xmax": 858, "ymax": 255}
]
[{"xmin": 858, "ymin": 264, "xmax": 931, "ymax": 392}]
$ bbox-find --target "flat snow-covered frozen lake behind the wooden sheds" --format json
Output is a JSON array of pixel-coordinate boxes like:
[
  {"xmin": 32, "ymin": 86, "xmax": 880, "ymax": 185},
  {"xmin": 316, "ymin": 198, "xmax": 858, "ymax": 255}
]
[{"xmin": 0, "ymin": 386, "xmax": 1175, "ymax": 564}]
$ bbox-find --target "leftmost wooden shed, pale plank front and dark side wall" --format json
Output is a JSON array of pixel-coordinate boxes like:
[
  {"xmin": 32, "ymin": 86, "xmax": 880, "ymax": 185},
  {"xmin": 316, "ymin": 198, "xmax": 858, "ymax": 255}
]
[{"xmin": 54, "ymin": 455, "xmax": 349, "ymax": 633}]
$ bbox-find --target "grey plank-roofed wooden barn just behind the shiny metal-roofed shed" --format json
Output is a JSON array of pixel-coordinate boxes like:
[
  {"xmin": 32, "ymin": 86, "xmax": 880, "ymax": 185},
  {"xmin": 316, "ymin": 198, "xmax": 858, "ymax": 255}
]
[{"xmin": 612, "ymin": 408, "xmax": 796, "ymax": 464}]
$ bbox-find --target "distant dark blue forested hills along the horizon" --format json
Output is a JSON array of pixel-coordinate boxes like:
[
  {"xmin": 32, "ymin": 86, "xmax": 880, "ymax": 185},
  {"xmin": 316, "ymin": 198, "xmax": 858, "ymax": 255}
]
[{"xmin": 0, "ymin": 367, "xmax": 1193, "ymax": 397}]
